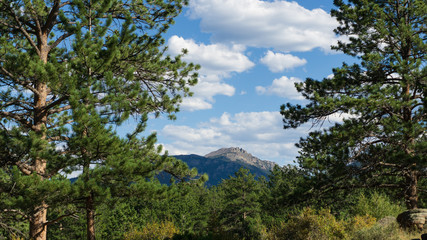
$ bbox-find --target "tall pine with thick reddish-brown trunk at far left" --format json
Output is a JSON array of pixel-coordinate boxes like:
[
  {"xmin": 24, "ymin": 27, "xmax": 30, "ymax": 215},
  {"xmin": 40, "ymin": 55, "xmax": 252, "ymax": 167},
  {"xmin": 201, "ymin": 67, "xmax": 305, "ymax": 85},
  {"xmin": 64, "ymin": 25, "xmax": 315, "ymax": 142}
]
[{"xmin": 0, "ymin": 0, "xmax": 198, "ymax": 239}]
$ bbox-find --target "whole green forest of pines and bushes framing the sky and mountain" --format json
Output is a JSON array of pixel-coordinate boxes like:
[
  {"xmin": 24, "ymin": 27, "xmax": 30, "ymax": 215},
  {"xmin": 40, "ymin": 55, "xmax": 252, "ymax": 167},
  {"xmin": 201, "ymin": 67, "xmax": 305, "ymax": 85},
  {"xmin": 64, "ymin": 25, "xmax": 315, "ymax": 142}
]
[{"xmin": 0, "ymin": 0, "xmax": 427, "ymax": 240}]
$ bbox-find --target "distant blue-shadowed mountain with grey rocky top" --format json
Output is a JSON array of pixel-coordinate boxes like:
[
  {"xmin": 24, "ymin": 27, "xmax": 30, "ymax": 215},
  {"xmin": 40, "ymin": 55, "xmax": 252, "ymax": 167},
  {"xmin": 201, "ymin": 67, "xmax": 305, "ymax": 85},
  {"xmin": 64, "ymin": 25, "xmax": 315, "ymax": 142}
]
[{"xmin": 174, "ymin": 147, "xmax": 275, "ymax": 186}]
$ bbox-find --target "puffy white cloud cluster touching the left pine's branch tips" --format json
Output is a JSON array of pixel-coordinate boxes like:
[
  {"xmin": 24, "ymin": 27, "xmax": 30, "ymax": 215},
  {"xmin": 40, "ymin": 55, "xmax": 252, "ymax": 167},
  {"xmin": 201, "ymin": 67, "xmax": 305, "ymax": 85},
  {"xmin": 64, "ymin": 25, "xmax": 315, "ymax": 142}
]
[{"xmin": 168, "ymin": 35, "xmax": 255, "ymax": 111}]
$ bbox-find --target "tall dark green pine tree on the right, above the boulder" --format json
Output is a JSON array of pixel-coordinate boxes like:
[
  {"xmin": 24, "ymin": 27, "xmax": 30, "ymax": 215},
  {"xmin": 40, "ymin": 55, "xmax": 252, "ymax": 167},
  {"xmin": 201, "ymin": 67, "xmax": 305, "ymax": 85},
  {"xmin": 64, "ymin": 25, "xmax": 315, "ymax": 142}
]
[{"xmin": 281, "ymin": 0, "xmax": 427, "ymax": 209}]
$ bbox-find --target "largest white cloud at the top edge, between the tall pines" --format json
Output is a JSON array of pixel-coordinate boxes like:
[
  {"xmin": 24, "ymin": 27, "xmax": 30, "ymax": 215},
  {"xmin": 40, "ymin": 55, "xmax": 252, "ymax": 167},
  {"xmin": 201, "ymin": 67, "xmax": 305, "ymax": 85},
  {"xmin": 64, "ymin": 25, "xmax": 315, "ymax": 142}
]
[{"xmin": 189, "ymin": 0, "xmax": 338, "ymax": 52}]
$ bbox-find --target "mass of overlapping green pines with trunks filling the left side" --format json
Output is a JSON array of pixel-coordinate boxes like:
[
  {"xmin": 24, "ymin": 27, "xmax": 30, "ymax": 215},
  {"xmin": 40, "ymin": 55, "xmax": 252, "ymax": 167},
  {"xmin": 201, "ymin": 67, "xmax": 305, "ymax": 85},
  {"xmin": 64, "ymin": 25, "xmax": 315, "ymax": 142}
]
[{"xmin": 0, "ymin": 0, "xmax": 199, "ymax": 239}]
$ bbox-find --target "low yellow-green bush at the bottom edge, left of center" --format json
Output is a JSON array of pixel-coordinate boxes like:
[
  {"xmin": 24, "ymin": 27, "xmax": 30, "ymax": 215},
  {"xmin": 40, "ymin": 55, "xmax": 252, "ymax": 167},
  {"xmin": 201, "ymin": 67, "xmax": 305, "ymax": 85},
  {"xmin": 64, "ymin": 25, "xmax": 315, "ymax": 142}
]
[{"xmin": 124, "ymin": 221, "xmax": 179, "ymax": 240}]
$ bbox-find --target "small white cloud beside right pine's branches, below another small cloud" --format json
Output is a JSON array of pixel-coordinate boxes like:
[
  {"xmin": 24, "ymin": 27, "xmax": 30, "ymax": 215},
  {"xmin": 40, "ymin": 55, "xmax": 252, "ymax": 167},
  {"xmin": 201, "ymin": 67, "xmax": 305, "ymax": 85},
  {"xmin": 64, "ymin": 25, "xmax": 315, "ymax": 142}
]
[{"xmin": 255, "ymin": 76, "xmax": 304, "ymax": 100}]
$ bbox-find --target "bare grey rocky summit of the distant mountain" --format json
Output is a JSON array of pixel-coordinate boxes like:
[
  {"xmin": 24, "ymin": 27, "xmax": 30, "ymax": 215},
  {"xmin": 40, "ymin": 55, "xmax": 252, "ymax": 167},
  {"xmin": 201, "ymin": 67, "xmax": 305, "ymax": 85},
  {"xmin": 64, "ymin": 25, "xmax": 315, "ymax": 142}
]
[{"xmin": 205, "ymin": 147, "xmax": 276, "ymax": 171}]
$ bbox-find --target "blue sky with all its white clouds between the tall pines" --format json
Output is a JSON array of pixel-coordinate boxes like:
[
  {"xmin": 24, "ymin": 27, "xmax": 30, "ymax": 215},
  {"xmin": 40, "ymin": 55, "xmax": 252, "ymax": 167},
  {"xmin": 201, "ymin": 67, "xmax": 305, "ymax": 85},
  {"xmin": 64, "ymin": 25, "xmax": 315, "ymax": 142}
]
[{"xmin": 127, "ymin": 0, "xmax": 354, "ymax": 165}]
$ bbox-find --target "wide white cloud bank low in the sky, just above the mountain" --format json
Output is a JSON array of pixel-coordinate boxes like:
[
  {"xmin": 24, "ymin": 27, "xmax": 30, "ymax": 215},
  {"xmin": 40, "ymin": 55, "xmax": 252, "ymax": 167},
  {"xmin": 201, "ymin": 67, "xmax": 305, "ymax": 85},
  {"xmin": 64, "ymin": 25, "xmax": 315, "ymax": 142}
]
[{"xmin": 158, "ymin": 112, "xmax": 310, "ymax": 165}]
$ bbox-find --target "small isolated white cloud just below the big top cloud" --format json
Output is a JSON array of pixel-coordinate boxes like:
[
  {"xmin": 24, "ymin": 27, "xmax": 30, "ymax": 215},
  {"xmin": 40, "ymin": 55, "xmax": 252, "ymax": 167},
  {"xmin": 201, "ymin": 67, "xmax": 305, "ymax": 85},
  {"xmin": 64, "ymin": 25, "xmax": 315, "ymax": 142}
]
[{"xmin": 261, "ymin": 51, "xmax": 307, "ymax": 72}]
